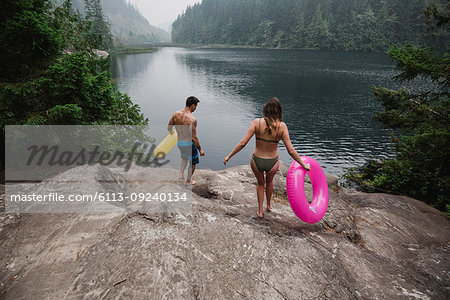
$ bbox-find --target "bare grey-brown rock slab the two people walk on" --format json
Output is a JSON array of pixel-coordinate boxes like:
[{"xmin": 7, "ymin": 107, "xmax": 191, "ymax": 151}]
[{"xmin": 0, "ymin": 164, "xmax": 450, "ymax": 299}]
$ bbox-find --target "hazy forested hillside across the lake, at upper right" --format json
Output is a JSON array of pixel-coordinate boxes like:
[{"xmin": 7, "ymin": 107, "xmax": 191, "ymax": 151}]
[{"xmin": 172, "ymin": 0, "xmax": 448, "ymax": 51}]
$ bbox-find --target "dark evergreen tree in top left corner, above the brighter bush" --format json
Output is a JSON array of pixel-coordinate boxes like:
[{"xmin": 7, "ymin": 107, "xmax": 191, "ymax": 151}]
[{"xmin": 0, "ymin": 0, "xmax": 64, "ymax": 82}]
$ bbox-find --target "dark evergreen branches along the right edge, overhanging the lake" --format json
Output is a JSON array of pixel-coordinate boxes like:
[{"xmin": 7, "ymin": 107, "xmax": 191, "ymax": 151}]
[{"xmin": 346, "ymin": 7, "xmax": 450, "ymax": 215}]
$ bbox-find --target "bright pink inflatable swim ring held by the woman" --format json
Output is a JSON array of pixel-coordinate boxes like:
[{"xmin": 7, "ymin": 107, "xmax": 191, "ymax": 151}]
[{"xmin": 286, "ymin": 156, "xmax": 328, "ymax": 224}]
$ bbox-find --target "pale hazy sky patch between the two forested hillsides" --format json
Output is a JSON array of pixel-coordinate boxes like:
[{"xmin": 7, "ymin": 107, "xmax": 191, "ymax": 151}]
[{"xmin": 127, "ymin": 0, "xmax": 201, "ymax": 26}]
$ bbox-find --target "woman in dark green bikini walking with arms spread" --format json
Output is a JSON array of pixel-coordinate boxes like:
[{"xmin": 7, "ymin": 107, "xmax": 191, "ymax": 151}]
[{"xmin": 223, "ymin": 98, "xmax": 311, "ymax": 218}]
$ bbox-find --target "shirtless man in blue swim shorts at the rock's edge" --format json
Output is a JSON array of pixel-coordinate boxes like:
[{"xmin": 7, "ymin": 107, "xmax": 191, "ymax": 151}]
[{"xmin": 167, "ymin": 96, "xmax": 205, "ymax": 185}]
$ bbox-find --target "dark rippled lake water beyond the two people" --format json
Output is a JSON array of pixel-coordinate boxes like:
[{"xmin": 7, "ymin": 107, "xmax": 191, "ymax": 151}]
[{"xmin": 112, "ymin": 48, "xmax": 398, "ymax": 175}]
